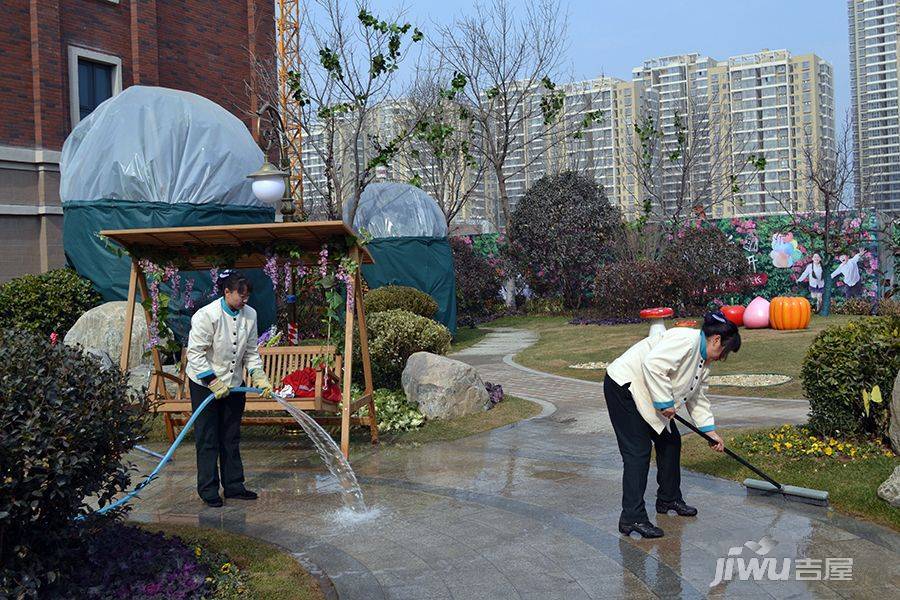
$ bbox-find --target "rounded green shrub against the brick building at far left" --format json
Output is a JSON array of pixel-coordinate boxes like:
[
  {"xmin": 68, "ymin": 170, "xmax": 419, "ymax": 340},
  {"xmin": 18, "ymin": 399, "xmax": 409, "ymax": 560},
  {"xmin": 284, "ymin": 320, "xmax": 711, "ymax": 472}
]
[{"xmin": 0, "ymin": 269, "xmax": 101, "ymax": 338}]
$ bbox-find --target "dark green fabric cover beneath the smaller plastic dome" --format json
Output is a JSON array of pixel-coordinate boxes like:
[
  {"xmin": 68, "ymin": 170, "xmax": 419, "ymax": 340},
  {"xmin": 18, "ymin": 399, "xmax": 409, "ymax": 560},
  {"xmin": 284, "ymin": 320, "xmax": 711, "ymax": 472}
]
[{"xmin": 362, "ymin": 237, "xmax": 456, "ymax": 335}]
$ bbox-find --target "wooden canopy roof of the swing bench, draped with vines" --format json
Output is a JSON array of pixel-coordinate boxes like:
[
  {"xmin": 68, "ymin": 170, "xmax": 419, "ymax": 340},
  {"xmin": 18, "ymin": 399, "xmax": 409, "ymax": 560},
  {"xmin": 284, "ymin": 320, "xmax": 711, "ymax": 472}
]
[{"xmin": 100, "ymin": 221, "xmax": 373, "ymax": 270}]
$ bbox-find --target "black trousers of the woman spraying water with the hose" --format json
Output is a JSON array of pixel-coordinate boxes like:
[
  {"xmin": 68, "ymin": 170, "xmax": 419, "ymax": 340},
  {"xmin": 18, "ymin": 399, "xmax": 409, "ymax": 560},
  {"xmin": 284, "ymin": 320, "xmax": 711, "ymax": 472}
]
[{"xmin": 190, "ymin": 381, "xmax": 246, "ymax": 500}]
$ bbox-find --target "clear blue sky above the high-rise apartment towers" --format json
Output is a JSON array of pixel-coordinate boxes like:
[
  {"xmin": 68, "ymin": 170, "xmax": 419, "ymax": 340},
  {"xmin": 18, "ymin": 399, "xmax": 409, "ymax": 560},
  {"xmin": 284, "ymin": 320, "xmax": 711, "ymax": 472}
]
[{"xmin": 374, "ymin": 0, "xmax": 850, "ymax": 122}]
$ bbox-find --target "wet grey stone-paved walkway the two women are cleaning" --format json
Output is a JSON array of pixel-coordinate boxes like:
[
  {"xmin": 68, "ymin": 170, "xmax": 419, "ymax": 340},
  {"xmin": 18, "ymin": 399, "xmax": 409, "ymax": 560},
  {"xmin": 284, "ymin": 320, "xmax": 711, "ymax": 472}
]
[{"xmin": 132, "ymin": 330, "xmax": 900, "ymax": 600}]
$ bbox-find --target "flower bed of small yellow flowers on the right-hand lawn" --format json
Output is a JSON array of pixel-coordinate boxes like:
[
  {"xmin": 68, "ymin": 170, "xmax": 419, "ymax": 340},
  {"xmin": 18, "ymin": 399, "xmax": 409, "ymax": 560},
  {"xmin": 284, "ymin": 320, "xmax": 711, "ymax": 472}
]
[{"xmin": 731, "ymin": 425, "xmax": 894, "ymax": 461}]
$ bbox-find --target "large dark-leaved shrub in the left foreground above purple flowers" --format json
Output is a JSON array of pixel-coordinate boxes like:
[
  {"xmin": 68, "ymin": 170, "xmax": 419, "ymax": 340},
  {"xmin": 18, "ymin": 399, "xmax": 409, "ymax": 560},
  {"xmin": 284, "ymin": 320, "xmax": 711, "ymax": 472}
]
[{"xmin": 0, "ymin": 330, "xmax": 148, "ymax": 597}]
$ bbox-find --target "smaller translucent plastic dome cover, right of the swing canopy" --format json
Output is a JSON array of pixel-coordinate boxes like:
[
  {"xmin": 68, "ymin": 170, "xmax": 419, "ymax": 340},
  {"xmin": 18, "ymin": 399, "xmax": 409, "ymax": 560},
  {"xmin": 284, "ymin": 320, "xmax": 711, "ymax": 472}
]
[{"xmin": 344, "ymin": 183, "xmax": 447, "ymax": 238}]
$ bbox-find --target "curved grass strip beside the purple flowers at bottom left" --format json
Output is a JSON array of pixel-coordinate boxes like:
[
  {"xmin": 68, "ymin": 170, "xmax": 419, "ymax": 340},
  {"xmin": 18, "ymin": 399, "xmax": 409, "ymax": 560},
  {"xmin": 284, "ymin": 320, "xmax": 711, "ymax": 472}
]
[{"xmin": 140, "ymin": 523, "xmax": 325, "ymax": 600}]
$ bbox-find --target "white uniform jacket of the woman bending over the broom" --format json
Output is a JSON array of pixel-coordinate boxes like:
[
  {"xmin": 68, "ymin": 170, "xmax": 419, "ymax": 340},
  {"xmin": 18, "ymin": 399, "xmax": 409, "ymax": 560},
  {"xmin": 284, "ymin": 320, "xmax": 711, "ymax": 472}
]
[{"xmin": 606, "ymin": 327, "xmax": 716, "ymax": 433}]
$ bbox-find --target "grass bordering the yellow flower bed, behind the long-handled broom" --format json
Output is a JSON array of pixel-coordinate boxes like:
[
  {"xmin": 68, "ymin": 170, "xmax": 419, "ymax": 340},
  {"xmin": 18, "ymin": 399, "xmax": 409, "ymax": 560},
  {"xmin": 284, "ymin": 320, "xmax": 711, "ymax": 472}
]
[{"xmin": 681, "ymin": 429, "xmax": 900, "ymax": 531}]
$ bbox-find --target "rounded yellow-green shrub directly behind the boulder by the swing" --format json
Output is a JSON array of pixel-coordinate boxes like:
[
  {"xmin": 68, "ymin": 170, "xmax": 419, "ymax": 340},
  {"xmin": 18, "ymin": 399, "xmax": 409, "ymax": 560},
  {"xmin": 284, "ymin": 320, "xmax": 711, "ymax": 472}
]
[{"xmin": 366, "ymin": 310, "xmax": 450, "ymax": 388}]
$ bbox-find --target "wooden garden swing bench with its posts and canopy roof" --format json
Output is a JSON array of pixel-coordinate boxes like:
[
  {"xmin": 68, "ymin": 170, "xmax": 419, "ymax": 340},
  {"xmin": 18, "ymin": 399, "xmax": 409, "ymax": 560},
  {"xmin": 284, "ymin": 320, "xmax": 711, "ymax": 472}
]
[{"xmin": 101, "ymin": 221, "xmax": 378, "ymax": 456}]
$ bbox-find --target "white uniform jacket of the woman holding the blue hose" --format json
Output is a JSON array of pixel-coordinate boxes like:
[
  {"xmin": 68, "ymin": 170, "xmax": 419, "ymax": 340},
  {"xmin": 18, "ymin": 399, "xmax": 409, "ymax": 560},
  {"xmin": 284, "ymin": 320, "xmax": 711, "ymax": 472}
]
[{"xmin": 187, "ymin": 298, "xmax": 263, "ymax": 387}]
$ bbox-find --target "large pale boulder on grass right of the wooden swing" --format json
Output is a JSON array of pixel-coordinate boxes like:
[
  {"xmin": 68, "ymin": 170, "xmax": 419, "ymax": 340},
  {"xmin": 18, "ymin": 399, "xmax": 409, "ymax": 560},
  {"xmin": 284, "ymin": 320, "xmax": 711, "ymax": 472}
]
[{"xmin": 401, "ymin": 352, "xmax": 490, "ymax": 419}]
